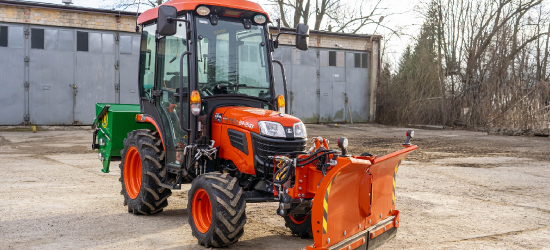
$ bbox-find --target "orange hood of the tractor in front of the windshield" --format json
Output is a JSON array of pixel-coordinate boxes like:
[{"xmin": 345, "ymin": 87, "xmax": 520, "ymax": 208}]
[{"xmin": 212, "ymin": 107, "xmax": 301, "ymax": 134}]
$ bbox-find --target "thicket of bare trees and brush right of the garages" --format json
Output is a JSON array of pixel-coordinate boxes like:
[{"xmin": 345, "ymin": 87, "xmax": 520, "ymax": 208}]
[{"xmin": 377, "ymin": 0, "xmax": 550, "ymax": 133}]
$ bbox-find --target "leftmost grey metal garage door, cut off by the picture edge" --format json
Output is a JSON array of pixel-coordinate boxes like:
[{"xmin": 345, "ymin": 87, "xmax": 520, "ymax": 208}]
[{"xmin": 0, "ymin": 23, "xmax": 26, "ymax": 125}]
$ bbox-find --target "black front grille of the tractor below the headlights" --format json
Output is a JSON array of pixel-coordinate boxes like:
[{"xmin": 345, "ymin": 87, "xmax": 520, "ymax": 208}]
[{"xmin": 250, "ymin": 133, "xmax": 307, "ymax": 176}]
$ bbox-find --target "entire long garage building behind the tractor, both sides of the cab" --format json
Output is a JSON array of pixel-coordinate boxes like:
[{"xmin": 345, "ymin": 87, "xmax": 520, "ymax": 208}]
[{"xmin": 0, "ymin": 0, "xmax": 380, "ymax": 125}]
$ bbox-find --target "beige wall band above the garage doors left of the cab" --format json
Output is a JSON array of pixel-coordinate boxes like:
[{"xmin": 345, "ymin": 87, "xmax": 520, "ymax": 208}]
[{"xmin": 0, "ymin": 4, "xmax": 136, "ymax": 32}]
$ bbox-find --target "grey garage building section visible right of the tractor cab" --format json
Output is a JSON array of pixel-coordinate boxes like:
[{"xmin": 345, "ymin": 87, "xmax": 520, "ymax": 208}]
[{"xmin": 270, "ymin": 30, "xmax": 380, "ymax": 123}]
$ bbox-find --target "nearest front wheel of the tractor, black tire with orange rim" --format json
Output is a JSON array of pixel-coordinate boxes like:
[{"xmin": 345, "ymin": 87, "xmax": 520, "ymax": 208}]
[{"xmin": 187, "ymin": 173, "xmax": 246, "ymax": 247}]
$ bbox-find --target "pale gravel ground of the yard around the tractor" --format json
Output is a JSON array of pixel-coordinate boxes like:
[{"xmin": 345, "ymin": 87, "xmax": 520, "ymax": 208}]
[{"xmin": 0, "ymin": 124, "xmax": 550, "ymax": 250}]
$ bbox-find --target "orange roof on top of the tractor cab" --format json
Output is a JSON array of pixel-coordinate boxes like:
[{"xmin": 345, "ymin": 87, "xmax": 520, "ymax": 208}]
[{"xmin": 138, "ymin": 0, "xmax": 270, "ymax": 24}]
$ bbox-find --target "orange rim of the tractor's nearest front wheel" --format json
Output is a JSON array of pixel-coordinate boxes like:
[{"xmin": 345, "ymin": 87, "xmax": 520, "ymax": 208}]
[{"xmin": 192, "ymin": 188, "xmax": 212, "ymax": 233}]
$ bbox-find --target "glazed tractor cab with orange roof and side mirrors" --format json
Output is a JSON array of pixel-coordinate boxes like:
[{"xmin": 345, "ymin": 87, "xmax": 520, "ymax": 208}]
[{"xmin": 138, "ymin": 0, "xmax": 309, "ymax": 170}]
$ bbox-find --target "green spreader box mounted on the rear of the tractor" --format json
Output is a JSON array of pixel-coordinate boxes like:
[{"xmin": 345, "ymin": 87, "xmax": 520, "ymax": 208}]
[{"xmin": 92, "ymin": 103, "xmax": 156, "ymax": 173}]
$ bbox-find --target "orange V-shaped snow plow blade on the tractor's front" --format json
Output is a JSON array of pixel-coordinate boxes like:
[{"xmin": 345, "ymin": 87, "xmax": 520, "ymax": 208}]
[{"xmin": 307, "ymin": 145, "xmax": 418, "ymax": 250}]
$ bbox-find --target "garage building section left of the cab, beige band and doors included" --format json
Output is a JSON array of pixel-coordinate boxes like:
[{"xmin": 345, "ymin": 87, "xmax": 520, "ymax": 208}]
[{"xmin": 0, "ymin": 0, "xmax": 140, "ymax": 125}]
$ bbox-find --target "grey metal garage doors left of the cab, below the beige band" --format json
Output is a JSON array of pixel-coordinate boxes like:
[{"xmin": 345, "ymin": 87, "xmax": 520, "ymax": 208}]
[{"xmin": 0, "ymin": 22, "xmax": 140, "ymax": 125}]
